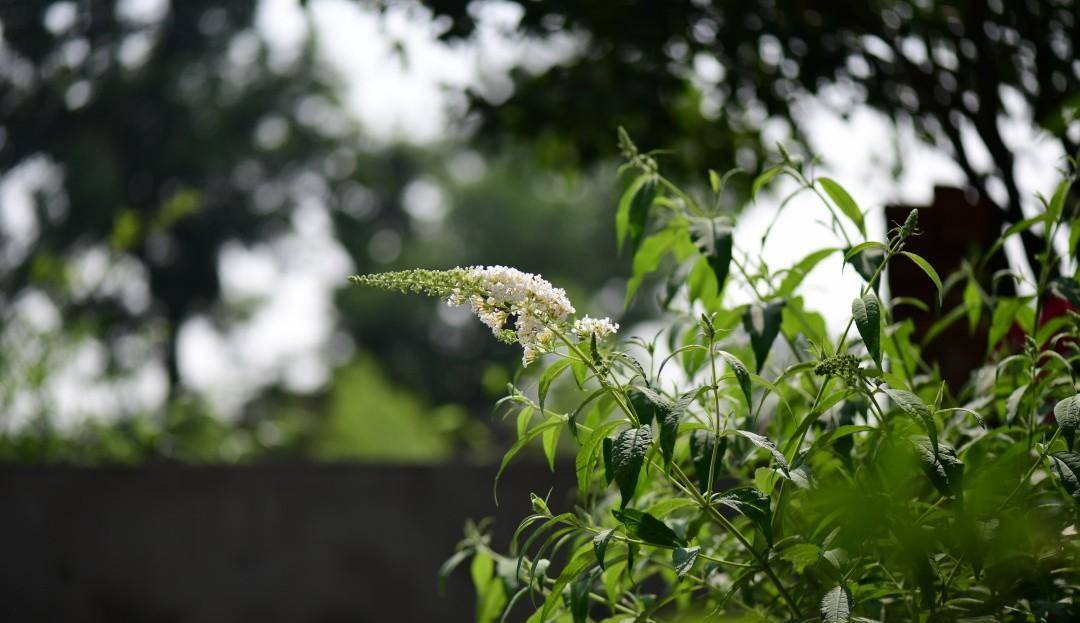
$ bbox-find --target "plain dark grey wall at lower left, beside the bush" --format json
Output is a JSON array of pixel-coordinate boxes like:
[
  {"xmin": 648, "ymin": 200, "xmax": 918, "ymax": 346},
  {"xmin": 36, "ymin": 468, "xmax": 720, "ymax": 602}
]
[{"xmin": 0, "ymin": 464, "xmax": 572, "ymax": 623}]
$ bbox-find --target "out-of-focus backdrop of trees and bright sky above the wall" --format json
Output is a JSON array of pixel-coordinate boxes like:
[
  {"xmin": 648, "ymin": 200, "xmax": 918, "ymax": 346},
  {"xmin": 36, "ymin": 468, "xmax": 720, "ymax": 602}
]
[{"xmin": 0, "ymin": 0, "xmax": 1080, "ymax": 464}]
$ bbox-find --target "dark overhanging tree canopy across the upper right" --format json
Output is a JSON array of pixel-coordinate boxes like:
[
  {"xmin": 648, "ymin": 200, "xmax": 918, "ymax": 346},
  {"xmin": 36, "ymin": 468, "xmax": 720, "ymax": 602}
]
[{"xmin": 432, "ymin": 0, "xmax": 1080, "ymax": 264}]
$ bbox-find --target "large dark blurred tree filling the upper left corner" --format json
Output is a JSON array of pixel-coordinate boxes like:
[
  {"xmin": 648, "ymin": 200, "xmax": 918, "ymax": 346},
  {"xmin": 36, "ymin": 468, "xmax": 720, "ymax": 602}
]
[{"xmin": 0, "ymin": 0, "xmax": 341, "ymax": 388}]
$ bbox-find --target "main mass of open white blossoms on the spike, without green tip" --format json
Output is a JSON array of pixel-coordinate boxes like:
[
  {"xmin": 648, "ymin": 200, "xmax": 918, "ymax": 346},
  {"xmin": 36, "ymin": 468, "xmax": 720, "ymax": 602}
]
[{"xmin": 446, "ymin": 266, "xmax": 575, "ymax": 366}]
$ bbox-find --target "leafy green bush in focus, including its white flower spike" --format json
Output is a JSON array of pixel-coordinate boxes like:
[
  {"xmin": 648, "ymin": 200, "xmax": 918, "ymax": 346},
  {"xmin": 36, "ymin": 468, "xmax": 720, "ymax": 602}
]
[{"xmin": 354, "ymin": 134, "xmax": 1080, "ymax": 623}]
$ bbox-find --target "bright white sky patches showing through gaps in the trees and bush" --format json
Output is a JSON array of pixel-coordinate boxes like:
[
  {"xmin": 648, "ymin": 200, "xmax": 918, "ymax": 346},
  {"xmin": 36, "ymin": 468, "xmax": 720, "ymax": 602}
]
[{"xmin": 0, "ymin": 0, "xmax": 1063, "ymax": 425}]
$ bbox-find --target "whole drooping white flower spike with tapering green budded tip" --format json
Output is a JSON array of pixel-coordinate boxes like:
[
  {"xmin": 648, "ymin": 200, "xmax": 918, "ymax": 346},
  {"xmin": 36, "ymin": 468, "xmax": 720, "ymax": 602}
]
[{"xmin": 351, "ymin": 266, "xmax": 619, "ymax": 366}]
